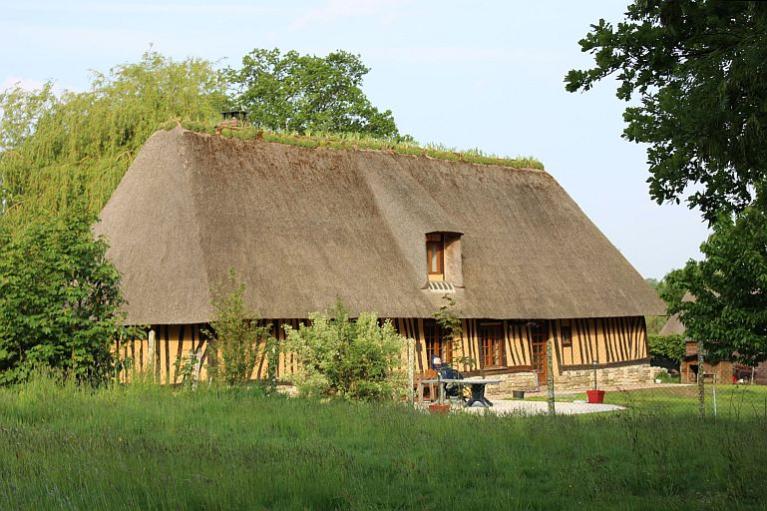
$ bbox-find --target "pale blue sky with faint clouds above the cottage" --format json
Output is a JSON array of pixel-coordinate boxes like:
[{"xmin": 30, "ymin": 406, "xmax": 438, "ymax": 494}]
[{"xmin": 0, "ymin": 0, "xmax": 707, "ymax": 278}]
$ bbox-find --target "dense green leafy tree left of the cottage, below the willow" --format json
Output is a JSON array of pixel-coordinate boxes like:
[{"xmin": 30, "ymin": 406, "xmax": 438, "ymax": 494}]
[{"xmin": 0, "ymin": 211, "xmax": 122, "ymax": 384}]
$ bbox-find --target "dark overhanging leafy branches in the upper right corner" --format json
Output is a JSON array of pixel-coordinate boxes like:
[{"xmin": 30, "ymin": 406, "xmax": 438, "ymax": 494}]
[{"xmin": 565, "ymin": 0, "xmax": 767, "ymax": 222}]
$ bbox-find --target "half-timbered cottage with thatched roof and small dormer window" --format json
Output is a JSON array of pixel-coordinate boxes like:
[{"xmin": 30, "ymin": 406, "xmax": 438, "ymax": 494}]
[{"xmin": 95, "ymin": 127, "xmax": 665, "ymax": 387}]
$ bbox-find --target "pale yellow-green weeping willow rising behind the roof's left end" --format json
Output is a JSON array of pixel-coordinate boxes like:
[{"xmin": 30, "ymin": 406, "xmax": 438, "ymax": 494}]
[{"xmin": 0, "ymin": 52, "xmax": 226, "ymax": 230}]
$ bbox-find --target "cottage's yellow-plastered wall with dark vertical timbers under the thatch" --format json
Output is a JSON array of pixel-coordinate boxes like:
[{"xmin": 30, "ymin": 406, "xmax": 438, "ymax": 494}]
[{"xmin": 116, "ymin": 316, "xmax": 649, "ymax": 384}]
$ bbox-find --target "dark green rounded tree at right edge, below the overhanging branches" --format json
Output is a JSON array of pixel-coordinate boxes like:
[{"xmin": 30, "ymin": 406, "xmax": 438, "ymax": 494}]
[{"xmin": 664, "ymin": 206, "xmax": 767, "ymax": 366}]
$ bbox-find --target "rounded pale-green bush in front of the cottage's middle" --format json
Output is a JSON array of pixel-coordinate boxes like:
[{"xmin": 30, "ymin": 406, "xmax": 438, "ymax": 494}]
[{"xmin": 285, "ymin": 304, "xmax": 405, "ymax": 400}]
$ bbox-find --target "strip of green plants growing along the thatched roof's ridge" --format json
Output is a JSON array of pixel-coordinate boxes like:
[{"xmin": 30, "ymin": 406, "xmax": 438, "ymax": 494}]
[{"xmin": 161, "ymin": 121, "xmax": 544, "ymax": 170}]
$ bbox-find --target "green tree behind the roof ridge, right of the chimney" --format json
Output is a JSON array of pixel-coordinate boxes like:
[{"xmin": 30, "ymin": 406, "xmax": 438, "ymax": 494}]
[{"xmin": 227, "ymin": 49, "xmax": 398, "ymax": 138}]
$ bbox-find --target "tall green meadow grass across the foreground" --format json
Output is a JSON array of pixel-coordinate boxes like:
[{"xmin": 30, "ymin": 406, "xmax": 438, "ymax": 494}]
[{"xmin": 0, "ymin": 381, "xmax": 767, "ymax": 510}]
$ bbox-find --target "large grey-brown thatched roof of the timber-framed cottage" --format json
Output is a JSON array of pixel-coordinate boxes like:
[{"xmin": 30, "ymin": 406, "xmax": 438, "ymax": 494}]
[{"xmin": 96, "ymin": 128, "xmax": 664, "ymax": 324}]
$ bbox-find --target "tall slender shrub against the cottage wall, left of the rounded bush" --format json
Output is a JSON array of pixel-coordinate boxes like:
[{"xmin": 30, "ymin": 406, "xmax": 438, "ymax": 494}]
[{"xmin": 207, "ymin": 270, "xmax": 275, "ymax": 385}]
